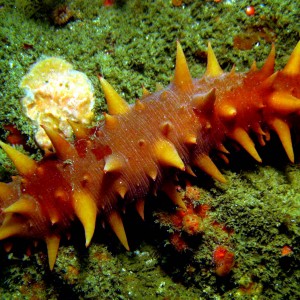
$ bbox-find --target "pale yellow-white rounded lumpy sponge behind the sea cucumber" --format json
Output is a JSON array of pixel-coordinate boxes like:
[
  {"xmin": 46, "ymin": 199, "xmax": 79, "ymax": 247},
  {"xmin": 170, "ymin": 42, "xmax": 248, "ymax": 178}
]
[{"xmin": 20, "ymin": 57, "xmax": 95, "ymax": 150}]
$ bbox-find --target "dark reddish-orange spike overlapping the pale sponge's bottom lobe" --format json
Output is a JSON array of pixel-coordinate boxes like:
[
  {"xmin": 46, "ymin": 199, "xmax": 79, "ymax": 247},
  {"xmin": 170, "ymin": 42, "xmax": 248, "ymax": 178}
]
[{"xmin": 42, "ymin": 125, "xmax": 76, "ymax": 160}]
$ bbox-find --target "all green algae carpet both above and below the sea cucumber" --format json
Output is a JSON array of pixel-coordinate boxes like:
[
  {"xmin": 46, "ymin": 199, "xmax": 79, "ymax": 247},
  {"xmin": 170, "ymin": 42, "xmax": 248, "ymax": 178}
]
[{"xmin": 0, "ymin": 0, "xmax": 300, "ymax": 299}]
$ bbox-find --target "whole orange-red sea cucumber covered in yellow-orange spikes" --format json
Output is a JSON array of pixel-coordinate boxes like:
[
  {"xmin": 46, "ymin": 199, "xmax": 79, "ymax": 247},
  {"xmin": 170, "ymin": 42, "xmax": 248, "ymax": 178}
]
[{"xmin": 0, "ymin": 42, "xmax": 300, "ymax": 274}]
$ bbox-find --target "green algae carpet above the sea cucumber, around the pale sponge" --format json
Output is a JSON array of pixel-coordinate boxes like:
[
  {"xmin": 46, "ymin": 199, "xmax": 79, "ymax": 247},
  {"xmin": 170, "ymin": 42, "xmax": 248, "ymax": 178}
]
[{"xmin": 0, "ymin": 0, "xmax": 299, "ymax": 150}]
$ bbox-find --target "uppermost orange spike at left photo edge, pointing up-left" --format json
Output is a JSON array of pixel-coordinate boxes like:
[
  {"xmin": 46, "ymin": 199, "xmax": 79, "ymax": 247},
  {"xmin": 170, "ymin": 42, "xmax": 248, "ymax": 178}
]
[{"xmin": 0, "ymin": 141, "xmax": 37, "ymax": 176}]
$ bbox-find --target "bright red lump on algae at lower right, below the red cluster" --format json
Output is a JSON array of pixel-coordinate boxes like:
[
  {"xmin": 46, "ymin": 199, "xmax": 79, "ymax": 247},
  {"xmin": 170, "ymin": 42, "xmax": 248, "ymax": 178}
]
[{"xmin": 213, "ymin": 246, "xmax": 234, "ymax": 276}]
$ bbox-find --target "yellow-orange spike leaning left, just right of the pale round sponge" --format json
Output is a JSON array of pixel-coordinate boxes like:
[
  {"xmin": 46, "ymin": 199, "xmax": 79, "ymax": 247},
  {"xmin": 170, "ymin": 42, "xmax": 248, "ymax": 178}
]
[{"xmin": 99, "ymin": 77, "xmax": 130, "ymax": 115}]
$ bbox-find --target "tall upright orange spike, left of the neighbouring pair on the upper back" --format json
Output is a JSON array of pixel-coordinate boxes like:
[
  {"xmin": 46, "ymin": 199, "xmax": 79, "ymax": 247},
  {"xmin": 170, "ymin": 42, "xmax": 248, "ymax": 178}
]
[{"xmin": 173, "ymin": 41, "xmax": 193, "ymax": 90}]
